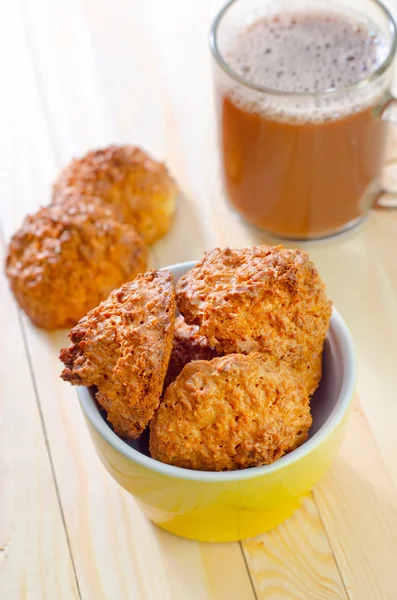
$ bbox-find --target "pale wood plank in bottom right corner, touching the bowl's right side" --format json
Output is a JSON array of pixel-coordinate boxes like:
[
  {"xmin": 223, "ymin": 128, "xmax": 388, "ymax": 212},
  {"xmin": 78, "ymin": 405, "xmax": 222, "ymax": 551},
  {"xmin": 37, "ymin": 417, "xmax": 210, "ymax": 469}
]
[{"xmin": 314, "ymin": 398, "xmax": 397, "ymax": 600}]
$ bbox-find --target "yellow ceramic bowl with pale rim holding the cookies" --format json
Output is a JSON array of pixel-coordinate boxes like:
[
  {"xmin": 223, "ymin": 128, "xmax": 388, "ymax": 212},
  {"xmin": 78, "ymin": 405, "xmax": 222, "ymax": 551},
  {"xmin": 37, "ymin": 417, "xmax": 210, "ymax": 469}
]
[{"xmin": 78, "ymin": 263, "xmax": 356, "ymax": 542}]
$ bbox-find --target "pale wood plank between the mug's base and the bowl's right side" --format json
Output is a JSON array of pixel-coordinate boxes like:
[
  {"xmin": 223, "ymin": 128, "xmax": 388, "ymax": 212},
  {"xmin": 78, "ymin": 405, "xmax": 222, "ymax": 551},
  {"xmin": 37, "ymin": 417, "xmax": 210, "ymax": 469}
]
[{"xmin": 309, "ymin": 219, "xmax": 397, "ymax": 486}]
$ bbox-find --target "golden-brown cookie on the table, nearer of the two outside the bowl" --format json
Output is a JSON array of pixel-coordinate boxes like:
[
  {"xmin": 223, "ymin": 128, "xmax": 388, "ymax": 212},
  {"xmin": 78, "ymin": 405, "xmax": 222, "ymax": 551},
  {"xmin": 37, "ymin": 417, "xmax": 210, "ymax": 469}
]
[{"xmin": 6, "ymin": 199, "xmax": 147, "ymax": 329}]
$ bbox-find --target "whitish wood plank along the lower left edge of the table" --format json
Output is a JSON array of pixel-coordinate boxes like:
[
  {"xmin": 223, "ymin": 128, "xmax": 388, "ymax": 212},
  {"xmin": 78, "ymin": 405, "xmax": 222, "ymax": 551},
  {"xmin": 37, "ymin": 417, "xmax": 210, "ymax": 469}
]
[{"xmin": 0, "ymin": 245, "xmax": 79, "ymax": 600}]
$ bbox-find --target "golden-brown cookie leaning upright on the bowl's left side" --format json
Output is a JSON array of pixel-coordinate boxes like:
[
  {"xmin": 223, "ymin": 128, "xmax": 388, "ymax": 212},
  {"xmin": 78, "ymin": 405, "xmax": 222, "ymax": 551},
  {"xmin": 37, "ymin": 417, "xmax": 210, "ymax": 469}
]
[{"xmin": 60, "ymin": 271, "xmax": 175, "ymax": 439}]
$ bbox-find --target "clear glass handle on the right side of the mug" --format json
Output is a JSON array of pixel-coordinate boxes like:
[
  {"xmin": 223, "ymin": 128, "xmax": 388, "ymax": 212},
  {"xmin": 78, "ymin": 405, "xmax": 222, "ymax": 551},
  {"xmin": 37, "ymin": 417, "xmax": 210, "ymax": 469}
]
[{"xmin": 374, "ymin": 94, "xmax": 397, "ymax": 210}]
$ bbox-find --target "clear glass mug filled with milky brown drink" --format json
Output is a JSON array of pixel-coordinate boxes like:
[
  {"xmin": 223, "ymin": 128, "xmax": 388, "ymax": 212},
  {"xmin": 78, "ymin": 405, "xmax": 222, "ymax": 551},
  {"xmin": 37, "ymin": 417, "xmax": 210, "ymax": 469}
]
[{"xmin": 210, "ymin": 0, "xmax": 396, "ymax": 240}]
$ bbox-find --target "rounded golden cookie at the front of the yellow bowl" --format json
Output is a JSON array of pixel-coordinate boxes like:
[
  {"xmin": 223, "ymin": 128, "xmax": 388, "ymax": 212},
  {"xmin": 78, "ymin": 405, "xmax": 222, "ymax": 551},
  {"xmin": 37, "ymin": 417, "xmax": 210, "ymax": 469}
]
[{"xmin": 150, "ymin": 353, "xmax": 312, "ymax": 471}]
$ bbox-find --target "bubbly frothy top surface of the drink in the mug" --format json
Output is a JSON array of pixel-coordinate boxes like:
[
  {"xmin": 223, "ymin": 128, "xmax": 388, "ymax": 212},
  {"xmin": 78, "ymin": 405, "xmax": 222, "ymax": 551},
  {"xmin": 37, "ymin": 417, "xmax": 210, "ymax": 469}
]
[{"xmin": 227, "ymin": 11, "xmax": 389, "ymax": 92}]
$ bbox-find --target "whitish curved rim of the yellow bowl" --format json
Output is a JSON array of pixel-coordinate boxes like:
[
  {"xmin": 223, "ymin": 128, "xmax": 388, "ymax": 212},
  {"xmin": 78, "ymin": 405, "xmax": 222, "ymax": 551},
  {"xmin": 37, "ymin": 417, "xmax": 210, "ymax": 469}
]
[{"xmin": 77, "ymin": 261, "xmax": 357, "ymax": 483}]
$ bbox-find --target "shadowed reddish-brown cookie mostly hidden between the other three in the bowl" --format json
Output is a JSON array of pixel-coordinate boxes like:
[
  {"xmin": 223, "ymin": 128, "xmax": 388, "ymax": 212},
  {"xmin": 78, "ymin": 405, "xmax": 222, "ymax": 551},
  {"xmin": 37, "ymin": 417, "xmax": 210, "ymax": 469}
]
[{"xmin": 164, "ymin": 316, "xmax": 218, "ymax": 388}]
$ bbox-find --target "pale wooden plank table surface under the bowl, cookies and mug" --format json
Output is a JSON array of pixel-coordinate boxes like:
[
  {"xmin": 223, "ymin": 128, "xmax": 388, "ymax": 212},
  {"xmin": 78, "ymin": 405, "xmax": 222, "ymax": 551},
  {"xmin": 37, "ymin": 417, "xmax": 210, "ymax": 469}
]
[{"xmin": 0, "ymin": 0, "xmax": 397, "ymax": 600}]
